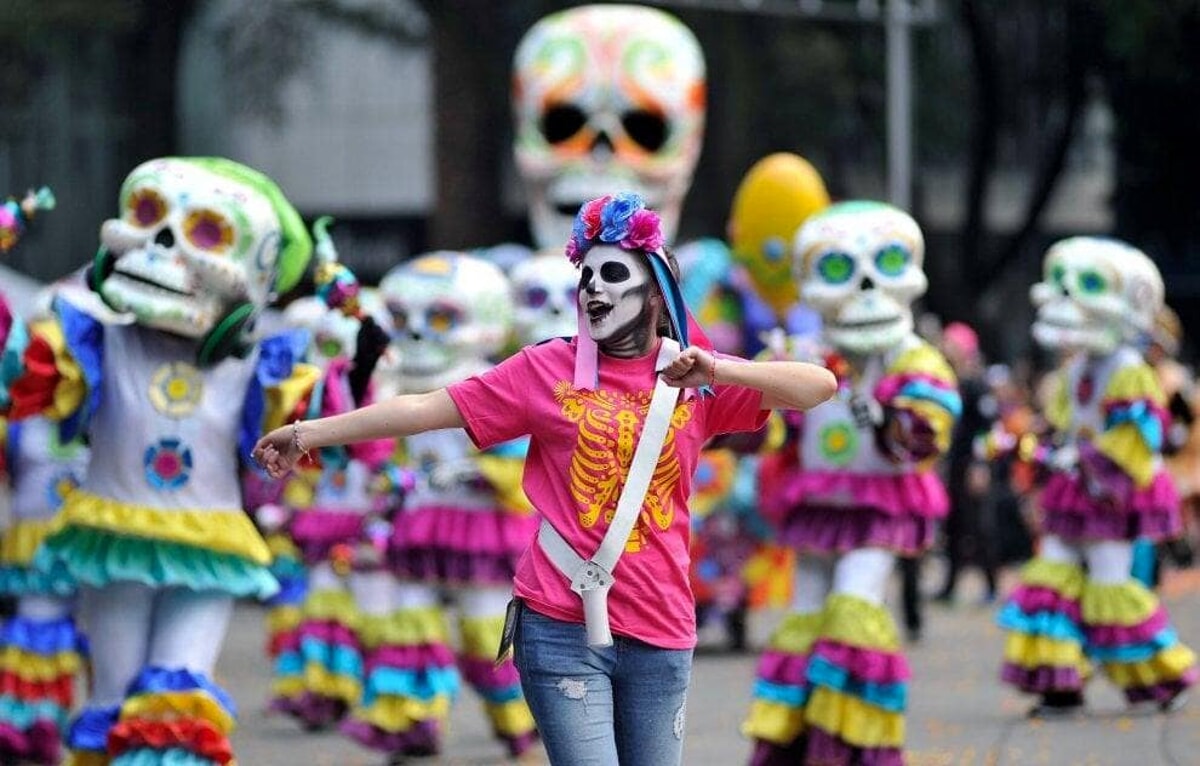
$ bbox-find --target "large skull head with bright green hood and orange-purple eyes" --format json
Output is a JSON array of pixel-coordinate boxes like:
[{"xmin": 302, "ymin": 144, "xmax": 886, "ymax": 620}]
[{"xmin": 90, "ymin": 157, "xmax": 312, "ymax": 361}]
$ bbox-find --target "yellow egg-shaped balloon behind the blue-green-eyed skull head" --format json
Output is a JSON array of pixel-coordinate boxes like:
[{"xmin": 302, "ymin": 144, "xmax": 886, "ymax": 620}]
[{"xmin": 726, "ymin": 151, "xmax": 829, "ymax": 321}]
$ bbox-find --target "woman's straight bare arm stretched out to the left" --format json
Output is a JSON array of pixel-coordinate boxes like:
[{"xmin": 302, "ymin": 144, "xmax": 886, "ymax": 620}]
[{"xmin": 252, "ymin": 389, "xmax": 464, "ymax": 479}]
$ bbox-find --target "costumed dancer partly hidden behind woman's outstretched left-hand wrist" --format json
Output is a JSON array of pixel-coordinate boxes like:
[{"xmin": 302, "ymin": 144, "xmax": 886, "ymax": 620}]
[{"xmin": 258, "ymin": 219, "xmax": 395, "ymax": 730}]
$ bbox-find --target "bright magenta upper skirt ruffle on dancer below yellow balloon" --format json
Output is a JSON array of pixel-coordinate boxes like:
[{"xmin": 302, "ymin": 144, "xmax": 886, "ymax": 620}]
[{"xmin": 763, "ymin": 471, "xmax": 950, "ymax": 519}]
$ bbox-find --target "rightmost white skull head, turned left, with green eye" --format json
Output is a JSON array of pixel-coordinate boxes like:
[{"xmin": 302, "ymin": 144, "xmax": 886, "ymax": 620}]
[{"xmin": 1030, "ymin": 237, "xmax": 1163, "ymax": 355}]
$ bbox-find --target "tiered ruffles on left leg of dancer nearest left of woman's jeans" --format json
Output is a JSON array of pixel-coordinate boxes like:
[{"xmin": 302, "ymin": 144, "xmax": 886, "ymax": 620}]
[{"xmin": 341, "ymin": 608, "xmax": 461, "ymax": 755}]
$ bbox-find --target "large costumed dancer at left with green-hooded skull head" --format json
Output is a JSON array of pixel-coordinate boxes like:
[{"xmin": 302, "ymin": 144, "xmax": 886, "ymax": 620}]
[{"xmin": 2, "ymin": 157, "xmax": 316, "ymax": 766}]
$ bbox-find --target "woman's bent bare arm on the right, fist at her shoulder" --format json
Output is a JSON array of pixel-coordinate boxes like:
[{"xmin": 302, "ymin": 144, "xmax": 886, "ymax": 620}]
[{"xmin": 662, "ymin": 346, "xmax": 838, "ymax": 409}]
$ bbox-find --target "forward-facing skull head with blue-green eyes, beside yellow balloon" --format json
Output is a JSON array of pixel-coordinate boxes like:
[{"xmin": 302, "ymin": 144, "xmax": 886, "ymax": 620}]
[{"xmin": 792, "ymin": 202, "xmax": 929, "ymax": 354}]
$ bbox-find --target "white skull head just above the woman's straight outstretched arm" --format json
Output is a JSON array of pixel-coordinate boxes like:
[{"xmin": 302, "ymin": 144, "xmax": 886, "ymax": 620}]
[{"xmin": 379, "ymin": 251, "xmax": 512, "ymax": 391}]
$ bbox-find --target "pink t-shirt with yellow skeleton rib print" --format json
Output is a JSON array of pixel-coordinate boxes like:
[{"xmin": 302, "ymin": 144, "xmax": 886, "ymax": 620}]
[{"xmin": 448, "ymin": 339, "xmax": 767, "ymax": 648}]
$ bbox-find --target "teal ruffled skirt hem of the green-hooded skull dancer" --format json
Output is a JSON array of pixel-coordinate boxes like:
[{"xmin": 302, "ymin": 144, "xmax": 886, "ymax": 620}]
[{"xmin": 34, "ymin": 527, "xmax": 280, "ymax": 599}]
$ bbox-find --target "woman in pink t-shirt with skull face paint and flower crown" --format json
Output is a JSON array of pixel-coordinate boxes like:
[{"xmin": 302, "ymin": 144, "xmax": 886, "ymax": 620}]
[{"xmin": 254, "ymin": 193, "xmax": 835, "ymax": 766}]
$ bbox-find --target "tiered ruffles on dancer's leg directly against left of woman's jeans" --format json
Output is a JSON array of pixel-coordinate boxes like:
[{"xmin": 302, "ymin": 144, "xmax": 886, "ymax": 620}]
[{"xmin": 458, "ymin": 615, "xmax": 536, "ymax": 758}]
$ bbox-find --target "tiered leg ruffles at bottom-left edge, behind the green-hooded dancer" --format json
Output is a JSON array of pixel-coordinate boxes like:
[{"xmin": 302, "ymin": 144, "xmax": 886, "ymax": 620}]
[{"xmin": 0, "ymin": 616, "xmax": 88, "ymax": 764}]
